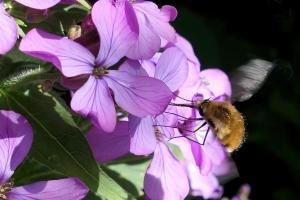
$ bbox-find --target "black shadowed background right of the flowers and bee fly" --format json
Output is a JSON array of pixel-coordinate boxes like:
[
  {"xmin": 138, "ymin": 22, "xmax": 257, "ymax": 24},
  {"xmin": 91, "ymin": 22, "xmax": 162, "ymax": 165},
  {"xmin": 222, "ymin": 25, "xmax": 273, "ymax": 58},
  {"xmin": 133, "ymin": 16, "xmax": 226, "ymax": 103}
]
[{"xmin": 156, "ymin": 0, "xmax": 300, "ymax": 200}]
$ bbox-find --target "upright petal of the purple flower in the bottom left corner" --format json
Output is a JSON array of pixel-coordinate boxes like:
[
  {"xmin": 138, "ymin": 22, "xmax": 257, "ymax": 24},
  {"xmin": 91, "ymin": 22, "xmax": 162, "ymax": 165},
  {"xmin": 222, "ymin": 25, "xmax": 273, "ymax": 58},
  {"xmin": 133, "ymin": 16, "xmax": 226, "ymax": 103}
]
[{"xmin": 0, "ymin": 110, "xmax": 33, "ymax": 185}]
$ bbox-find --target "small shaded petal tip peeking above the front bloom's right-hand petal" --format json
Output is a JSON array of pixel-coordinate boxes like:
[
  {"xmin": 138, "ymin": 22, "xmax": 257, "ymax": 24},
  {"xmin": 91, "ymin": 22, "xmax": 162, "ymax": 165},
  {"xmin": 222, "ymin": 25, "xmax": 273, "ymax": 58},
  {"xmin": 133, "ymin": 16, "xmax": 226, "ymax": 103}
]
[{"xmin": 119, "ymin": 59, "xmax": 148, "ymax": 76}]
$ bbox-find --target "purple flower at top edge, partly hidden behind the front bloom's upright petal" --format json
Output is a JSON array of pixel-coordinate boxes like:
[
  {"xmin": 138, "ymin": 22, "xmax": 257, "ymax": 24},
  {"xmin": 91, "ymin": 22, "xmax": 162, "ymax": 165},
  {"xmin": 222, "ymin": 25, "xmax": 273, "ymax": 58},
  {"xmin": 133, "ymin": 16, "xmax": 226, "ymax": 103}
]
[{"xmin": 126, "ymin": 1, "xmax": 177, "ymax": 59}]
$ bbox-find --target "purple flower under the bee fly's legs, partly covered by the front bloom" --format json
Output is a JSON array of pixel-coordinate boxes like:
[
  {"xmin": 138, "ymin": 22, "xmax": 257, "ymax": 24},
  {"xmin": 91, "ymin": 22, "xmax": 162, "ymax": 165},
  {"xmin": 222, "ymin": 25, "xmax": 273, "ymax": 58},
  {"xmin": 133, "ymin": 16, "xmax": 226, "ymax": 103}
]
[{"xmin": 87, "ymin": 47, "xmax": 189, "ymax": 200}]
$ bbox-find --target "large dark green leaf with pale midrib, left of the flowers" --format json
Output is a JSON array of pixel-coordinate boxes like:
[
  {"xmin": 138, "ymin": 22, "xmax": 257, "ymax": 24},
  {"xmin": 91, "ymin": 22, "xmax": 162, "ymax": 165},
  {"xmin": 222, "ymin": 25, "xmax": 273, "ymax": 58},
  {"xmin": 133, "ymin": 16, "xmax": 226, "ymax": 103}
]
[{"xmin": 0, "ymin": 88, "xmax": 99, "ymax": 191}]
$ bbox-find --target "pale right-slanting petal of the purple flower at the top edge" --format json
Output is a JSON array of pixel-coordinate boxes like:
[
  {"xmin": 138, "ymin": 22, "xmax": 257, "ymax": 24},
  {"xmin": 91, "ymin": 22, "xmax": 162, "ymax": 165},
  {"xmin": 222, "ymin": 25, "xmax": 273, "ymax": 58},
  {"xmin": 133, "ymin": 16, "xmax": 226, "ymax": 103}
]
[{"xmin": 133, "ymin": 1, "xmax": 176, "ymax": 42}]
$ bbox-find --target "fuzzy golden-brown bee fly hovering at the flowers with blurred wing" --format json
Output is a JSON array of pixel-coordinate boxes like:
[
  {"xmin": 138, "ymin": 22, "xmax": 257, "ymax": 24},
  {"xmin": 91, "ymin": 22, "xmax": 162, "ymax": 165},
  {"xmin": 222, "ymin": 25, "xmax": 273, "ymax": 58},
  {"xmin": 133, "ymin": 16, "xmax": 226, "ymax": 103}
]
[{"xmin": 170, "ymin": 59, "xmax": 273, "ymax": 152}]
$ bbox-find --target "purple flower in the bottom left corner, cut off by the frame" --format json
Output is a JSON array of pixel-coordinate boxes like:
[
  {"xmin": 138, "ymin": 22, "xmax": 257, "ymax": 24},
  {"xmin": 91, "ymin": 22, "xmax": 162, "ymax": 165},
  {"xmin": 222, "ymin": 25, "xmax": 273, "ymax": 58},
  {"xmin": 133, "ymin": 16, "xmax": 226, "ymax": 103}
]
[{"xmin": 0, "ymin": 110, "xmax": 88, "ymax": 200}]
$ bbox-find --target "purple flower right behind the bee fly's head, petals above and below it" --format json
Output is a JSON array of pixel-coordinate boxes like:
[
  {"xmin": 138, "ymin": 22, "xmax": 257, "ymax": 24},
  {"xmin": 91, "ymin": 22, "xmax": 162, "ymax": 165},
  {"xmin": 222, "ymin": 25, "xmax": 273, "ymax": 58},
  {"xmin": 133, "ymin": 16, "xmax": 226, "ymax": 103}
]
[{"xmin": 175, "ymin": 69, "xmax": 231, "ymax": 175}]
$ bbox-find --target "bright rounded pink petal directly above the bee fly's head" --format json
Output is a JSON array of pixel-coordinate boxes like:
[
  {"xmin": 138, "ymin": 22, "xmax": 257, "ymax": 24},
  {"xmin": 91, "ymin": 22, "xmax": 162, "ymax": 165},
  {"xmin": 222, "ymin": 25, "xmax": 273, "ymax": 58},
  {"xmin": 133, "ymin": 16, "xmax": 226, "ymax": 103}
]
[{"xmin": 198, "ymin": 69, "xmax": 231, "ymax": 98}]
